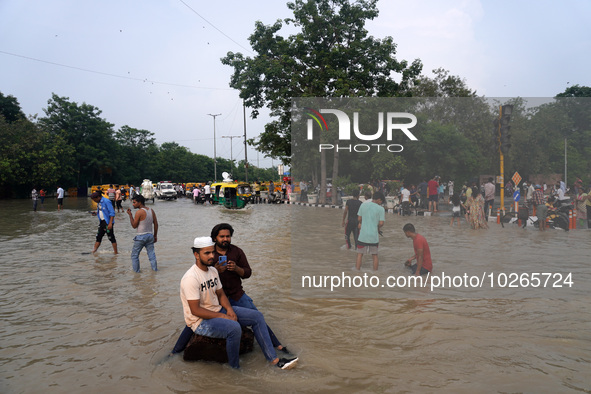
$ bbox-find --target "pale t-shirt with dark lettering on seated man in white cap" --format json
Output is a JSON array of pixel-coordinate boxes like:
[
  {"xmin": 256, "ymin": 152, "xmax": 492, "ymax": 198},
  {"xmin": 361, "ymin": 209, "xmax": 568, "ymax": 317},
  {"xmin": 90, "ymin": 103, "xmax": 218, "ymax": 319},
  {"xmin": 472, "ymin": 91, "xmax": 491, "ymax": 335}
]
[{"xmin": 181, "ymin": 264, "xmax": 222, "ymax": 331}]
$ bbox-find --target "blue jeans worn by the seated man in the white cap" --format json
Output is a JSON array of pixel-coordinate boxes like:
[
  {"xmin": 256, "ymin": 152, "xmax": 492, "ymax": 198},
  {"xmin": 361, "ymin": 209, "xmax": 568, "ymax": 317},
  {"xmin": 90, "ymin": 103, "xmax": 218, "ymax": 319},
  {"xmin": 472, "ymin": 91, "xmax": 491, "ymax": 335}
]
[{"xmin": 195, "ymin": 306, "xmax": 277, "ymax": 368}]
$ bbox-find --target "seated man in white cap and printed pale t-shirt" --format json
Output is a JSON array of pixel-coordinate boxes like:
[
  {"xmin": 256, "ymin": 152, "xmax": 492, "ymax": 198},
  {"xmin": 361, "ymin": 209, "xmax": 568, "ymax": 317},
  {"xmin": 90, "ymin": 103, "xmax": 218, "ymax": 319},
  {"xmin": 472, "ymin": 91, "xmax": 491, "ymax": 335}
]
[{"xmin": 176, "ymin": 237, "xmax": 298, "ymax": 369}]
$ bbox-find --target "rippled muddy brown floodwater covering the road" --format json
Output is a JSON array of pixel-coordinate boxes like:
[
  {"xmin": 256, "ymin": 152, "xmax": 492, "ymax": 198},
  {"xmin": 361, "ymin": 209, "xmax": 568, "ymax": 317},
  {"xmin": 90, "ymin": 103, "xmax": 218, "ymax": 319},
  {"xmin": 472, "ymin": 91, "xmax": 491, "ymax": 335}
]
[{"xmin": 0, "ymin": 199, "xmax": 591, "ymax": 393}]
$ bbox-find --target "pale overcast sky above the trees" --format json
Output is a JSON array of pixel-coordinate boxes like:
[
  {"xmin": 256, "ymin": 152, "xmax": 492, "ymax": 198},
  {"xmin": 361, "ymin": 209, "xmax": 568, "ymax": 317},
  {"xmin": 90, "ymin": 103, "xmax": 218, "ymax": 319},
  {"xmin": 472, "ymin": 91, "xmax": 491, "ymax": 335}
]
[{"xmin": 0, "ymin": 0, "xmax": 591, "ymax": 167}]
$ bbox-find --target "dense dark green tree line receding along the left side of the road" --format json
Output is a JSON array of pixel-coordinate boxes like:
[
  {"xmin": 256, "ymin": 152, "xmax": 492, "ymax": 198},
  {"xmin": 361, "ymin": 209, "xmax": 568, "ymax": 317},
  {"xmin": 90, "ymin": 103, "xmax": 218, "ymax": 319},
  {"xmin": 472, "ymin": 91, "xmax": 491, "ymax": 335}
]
[{"xmin": 0, "ymin": 92, "xmax": 277, "ymax": 197}]
